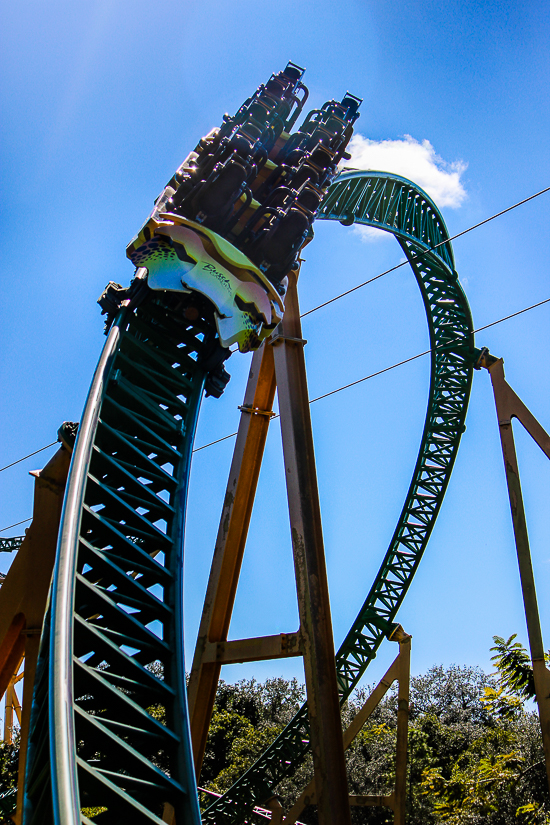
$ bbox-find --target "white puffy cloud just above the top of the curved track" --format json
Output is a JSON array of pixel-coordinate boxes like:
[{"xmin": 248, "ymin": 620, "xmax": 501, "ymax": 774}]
[{"xmin": 346, "ymin": 134, "xmax": 468, "ymax": 208}]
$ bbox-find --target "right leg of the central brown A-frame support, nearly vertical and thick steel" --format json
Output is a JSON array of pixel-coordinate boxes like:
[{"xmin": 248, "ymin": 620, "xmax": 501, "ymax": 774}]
[{"xmin": 273, "ymin": 277, "xmax": 351, "ymax": 825}]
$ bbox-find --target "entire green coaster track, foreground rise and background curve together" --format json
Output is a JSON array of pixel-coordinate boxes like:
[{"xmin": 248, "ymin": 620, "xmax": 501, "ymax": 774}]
[{"xmin": 18, "ymin": 172, "xmax": 473, "ymax": 825}]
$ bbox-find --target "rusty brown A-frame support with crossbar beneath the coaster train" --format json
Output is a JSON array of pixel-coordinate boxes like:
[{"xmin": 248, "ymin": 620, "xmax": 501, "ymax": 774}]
[{"xmin": 189, "ymin": 273, "xmax": 350, "ymax": 825}]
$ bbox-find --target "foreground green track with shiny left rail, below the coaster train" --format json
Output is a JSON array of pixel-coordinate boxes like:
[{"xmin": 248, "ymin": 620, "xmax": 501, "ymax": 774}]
[{"xmin": 24, "ymin": 295, "xmax": 215, "ymax": 825}]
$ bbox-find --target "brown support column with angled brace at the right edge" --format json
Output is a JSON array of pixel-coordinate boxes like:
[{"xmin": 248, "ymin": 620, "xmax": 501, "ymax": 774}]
[{"xmin": 486, "ymin": 351, "xmax": 550, "ymax": 788}]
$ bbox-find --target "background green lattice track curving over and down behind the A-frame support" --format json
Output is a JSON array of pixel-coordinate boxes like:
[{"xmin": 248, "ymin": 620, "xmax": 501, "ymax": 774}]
[{"xmin": 203, "ymin": 172, "xmax": 474, "ymax": 825}]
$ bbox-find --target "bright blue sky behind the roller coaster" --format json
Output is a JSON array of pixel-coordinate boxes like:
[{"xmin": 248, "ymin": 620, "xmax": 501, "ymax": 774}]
[{"xmin": 0, "ymin": 0, "xmax": 550, "ymax": 692}]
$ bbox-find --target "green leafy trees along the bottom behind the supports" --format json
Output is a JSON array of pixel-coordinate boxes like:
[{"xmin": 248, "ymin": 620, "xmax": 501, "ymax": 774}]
[{"xmin": 201, "ymin": 652, "xmax": 550, "ymax": 825}]
